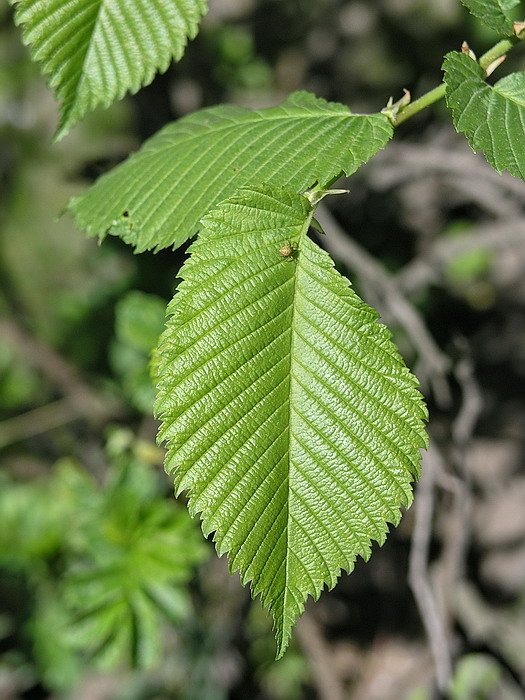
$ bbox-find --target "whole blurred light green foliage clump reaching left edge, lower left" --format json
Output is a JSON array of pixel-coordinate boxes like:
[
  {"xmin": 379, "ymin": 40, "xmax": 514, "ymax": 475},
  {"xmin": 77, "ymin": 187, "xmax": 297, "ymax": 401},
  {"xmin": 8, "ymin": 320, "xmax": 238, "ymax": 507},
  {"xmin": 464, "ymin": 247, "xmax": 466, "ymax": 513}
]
[{"xmin": 0, "ymin": 430, "xmax": 206, "ymax": 687}]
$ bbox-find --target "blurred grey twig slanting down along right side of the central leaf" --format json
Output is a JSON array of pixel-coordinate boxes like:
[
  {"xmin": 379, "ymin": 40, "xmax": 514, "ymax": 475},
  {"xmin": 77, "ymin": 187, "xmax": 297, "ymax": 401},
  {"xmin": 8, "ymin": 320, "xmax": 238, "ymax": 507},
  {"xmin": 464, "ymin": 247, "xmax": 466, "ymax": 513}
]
[{"xmin": 316, "ymin": 204, "xmax": 450, "ymax": 407}]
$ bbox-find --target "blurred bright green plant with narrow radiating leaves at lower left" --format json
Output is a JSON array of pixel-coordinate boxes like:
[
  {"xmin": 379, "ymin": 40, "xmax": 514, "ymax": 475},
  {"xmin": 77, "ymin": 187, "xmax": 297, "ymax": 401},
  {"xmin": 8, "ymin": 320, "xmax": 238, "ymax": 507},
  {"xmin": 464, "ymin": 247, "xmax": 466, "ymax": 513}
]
[{"xmin": 61, "ymin": 453, "xmax": 206, "ymax": 668}]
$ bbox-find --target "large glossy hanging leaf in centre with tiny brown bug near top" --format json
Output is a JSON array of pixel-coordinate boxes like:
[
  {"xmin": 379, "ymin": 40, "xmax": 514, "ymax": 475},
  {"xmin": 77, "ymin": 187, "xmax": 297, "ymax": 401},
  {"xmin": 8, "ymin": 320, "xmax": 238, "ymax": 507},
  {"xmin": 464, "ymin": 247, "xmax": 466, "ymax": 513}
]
[{"xmin": 156, "ymin": 185, "xmax": 426, "ymax": 656}]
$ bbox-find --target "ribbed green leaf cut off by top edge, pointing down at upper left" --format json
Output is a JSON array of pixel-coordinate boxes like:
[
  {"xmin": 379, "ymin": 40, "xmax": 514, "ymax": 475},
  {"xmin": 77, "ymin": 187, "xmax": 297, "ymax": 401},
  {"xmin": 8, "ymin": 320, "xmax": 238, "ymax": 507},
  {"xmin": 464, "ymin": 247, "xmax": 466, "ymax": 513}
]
[{"xmin": 10, "ymin": 0, "xmax": 207, "ymax": 139}]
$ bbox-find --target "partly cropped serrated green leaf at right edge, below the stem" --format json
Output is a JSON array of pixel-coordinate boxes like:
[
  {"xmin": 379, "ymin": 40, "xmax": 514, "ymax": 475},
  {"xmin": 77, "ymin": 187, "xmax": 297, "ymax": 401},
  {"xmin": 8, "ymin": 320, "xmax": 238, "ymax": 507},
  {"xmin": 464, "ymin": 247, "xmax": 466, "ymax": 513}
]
[{"xmin": 443, "ymin": 51, "xmax": 525, "ymax": 180}]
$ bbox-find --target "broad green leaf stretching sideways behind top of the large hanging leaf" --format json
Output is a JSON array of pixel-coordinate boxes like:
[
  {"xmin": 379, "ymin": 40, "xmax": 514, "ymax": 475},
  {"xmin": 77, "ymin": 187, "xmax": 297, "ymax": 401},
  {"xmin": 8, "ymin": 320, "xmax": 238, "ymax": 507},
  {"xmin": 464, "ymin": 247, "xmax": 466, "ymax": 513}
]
[{"xmin": 69, "ymin": 92, "xmax": 392, "ymax": 252}]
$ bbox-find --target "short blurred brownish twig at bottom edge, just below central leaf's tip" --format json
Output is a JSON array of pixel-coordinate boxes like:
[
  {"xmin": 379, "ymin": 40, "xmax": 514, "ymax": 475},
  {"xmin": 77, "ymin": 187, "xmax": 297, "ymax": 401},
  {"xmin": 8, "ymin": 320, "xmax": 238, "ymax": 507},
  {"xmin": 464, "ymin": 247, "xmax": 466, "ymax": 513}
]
[{"xmin": 297, "ymin": 612, "xmax": 346, "ymax": 700}]
